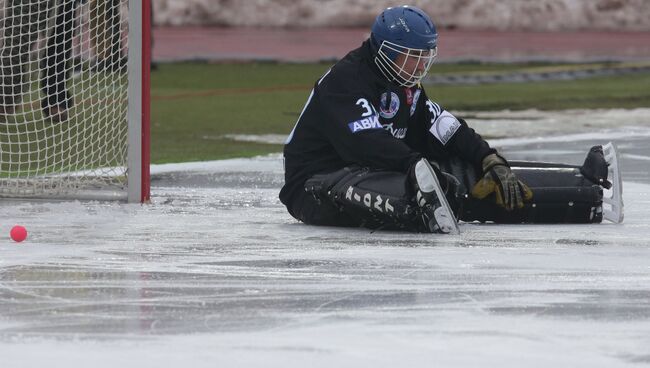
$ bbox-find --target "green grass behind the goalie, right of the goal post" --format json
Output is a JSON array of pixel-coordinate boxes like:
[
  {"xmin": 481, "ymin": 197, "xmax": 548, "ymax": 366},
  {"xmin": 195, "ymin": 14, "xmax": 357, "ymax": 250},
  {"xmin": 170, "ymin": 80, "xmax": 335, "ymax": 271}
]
[{"xmin": 147, "ymin": 63, "xmax": 650, "ymax": 163}]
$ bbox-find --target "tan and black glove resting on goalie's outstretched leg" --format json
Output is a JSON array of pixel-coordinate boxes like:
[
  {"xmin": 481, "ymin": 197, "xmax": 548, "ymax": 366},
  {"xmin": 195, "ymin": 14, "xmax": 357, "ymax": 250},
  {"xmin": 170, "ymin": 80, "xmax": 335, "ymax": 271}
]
[{"xmin": 472, "ymin": 153, "xmax": 533, "ymax": 211}]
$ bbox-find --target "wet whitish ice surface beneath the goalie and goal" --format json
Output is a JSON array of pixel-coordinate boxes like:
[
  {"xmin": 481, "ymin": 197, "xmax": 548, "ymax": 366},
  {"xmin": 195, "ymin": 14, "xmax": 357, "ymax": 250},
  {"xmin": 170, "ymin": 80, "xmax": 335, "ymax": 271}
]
[{"xmin": 0, "ymin": 127, "xmax": 650, "ymax": 368}]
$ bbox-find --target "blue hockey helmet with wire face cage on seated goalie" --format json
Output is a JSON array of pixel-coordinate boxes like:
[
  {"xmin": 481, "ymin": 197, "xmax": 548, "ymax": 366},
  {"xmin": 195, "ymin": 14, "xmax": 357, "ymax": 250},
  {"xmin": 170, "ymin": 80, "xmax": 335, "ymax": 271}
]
[{"xmin": 370, "ymin": 5, "xmax": 438, "ymax": 87}]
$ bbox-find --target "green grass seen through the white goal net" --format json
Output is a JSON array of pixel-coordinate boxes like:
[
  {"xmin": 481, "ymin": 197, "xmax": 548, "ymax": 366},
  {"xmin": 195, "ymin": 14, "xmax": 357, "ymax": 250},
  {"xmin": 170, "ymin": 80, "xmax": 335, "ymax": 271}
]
[{"xmin": 0, "ymin": 67, "xmax": 127, "ymax": 178}]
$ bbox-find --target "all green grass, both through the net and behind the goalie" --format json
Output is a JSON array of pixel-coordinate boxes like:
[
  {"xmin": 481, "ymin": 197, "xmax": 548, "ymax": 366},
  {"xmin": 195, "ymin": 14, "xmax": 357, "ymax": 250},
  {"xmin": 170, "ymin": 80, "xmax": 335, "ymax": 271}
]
[{"xmin": 0, "ymin": 63, "xmax": 650, "ymax": 173}]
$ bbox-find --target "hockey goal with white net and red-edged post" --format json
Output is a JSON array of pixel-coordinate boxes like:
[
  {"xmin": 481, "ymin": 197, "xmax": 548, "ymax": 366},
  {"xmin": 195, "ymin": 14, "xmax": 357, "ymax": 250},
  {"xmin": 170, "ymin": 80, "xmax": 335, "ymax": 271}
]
[{"xmin": 0, "ymin": 0, "xmax": 150, "ymax": 202}]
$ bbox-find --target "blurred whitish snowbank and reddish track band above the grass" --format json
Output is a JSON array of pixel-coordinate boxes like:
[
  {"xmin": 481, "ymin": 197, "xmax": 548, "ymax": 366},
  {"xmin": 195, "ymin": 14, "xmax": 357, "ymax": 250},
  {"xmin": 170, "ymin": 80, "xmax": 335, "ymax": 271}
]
[{"xmin": 153, "ymin": 0, "xmax": 650, "ymax": 62}]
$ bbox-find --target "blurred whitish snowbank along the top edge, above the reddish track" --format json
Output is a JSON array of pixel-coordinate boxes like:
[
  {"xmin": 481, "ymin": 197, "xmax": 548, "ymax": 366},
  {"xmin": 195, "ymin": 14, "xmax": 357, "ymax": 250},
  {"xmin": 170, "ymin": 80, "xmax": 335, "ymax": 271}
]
[{"xmin": 153, "ymin": 0, "xmax": 650, "ymax": 31}]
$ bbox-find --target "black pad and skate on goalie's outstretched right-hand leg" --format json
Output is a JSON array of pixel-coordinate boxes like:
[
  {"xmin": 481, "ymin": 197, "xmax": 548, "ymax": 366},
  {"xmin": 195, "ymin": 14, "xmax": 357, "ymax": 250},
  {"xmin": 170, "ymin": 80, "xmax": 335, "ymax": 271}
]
[{"xmin": 441, "ymin": 145, "xmax": 622, "ymax": 223}]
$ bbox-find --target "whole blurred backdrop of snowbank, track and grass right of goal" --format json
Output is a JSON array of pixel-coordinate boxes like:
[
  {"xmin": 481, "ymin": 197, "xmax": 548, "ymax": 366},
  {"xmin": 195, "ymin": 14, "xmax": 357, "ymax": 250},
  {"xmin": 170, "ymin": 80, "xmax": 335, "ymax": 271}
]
[{"xmin": 147, "ymin": 0, "xmax": 650, "ymax": 162}]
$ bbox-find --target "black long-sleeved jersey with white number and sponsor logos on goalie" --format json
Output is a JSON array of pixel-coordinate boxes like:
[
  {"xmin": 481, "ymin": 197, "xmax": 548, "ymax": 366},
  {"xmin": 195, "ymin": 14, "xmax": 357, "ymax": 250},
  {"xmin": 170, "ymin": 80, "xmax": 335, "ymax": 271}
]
[{"xmin": 280, "ymin": 41, "xmax": 494, "ymax": 206}]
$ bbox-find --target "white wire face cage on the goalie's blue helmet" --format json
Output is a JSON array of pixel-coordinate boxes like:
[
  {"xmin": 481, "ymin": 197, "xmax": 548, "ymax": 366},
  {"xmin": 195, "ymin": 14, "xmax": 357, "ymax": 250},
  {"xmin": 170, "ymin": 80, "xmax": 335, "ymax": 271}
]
[{"xmin": 375, "ymin": 41, "xmax": 438, "ymax": 87}]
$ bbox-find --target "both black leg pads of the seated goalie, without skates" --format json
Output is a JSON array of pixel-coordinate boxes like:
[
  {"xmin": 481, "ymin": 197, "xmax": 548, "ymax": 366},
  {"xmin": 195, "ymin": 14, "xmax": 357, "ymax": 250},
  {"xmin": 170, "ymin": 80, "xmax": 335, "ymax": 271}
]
[{"xmin": 289, "ymin": 160, "xmax": 603, "ymax": 231}]
